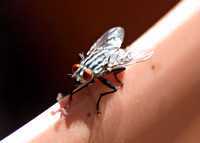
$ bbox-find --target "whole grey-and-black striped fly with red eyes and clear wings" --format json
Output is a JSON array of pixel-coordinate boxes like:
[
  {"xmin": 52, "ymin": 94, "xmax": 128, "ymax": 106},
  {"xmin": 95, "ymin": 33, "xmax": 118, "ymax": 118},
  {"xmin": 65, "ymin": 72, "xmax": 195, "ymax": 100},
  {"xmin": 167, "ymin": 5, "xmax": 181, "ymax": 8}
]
[{"xmin": 68, "ymin": 27, "xmax": 153, "ymax": 115}]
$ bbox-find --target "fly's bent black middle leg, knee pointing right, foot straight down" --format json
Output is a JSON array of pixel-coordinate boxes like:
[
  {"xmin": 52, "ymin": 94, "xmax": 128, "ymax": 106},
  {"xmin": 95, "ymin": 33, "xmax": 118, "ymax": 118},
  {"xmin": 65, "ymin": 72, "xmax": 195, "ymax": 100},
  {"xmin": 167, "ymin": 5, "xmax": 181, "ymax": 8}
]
[{"xmin": 97, "ymin": 77, "xmax": 117, "ymax": 116}]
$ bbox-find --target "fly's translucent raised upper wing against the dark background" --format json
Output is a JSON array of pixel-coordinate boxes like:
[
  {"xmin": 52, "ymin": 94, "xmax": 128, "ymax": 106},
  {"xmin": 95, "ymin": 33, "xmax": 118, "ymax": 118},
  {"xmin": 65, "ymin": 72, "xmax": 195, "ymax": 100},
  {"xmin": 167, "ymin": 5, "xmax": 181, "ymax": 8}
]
[{"xmin": 87, "ymin": 27, "xmax": 124, "ymax": 56}]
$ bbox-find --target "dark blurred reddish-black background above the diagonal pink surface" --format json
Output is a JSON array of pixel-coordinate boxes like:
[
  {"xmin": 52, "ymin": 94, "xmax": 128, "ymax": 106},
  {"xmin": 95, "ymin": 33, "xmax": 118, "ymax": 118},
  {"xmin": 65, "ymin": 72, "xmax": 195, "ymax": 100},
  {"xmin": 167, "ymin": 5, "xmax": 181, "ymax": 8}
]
[{"xmin": 0, "ymin": 0, "xmax": 178, "ymax": 139}]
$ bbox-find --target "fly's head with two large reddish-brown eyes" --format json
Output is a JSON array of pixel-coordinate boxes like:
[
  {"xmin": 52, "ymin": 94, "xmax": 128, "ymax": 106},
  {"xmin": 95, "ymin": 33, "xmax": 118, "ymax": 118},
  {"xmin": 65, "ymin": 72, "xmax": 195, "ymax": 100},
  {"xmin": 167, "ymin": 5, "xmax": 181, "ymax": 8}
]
[{"xmin": 72, "ymin": 64, "xmax": 94, "ymax": 83}]
